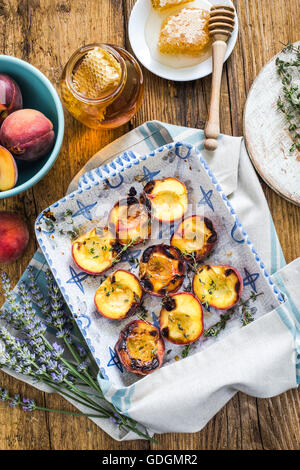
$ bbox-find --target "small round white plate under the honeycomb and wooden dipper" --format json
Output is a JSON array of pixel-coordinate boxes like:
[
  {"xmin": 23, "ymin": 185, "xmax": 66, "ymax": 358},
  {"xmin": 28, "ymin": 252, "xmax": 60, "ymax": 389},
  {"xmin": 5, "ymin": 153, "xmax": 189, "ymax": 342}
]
[{"xmin": 128, "ymin": 0, "xmax": 238, "ymax": 82}]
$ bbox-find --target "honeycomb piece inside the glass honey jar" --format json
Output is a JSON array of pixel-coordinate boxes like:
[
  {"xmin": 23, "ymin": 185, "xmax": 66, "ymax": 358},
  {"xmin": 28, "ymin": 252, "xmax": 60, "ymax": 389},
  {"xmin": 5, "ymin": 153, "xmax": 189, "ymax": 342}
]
[{"xmin": 73, "ymin": 47, "xmax": 121, "ymax": 99}]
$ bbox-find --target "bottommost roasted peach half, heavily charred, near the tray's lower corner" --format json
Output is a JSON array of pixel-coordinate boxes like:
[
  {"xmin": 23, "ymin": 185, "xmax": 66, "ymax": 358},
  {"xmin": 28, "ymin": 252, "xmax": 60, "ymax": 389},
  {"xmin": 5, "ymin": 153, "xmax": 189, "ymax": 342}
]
[{"xmin": 115, "ymin": 320, "xmax": 165, "ymax": 375}]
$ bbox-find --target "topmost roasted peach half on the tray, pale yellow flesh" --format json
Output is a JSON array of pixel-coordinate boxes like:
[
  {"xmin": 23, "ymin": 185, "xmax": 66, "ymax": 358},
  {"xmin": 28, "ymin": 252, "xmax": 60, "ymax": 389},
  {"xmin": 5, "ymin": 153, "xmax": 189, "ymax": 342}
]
[{"xmin": 142, "ymin": 178, "xmax": 188, "ymax": 222}]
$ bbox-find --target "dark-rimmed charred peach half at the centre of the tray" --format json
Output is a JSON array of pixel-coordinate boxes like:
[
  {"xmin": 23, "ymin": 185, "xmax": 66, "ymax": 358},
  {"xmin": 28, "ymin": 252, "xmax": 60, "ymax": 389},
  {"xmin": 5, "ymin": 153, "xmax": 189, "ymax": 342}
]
[{"xmin": 139, "ymin": 244, "xmax": 185, "ymax": 297}]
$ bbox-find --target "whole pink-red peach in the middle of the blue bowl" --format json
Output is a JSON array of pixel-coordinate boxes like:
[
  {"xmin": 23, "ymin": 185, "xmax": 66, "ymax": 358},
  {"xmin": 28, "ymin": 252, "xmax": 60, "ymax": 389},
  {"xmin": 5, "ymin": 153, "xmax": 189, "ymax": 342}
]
[{"xmin": 0, "ymin": 109, "xmax": 55, "ymax": 161}]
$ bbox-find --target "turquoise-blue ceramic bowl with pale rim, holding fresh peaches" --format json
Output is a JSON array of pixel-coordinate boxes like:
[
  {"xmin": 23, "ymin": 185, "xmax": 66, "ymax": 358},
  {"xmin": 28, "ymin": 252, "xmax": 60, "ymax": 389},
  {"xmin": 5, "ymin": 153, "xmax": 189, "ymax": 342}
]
[{"xmin": 0, "ymin": 55, "xmax": 65, "ymax": 199}]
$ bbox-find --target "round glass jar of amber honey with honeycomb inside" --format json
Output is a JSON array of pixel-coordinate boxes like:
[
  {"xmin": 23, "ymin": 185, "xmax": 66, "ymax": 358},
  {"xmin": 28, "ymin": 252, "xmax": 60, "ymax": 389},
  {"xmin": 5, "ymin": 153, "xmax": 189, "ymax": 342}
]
[{"xmin": 60, "ymin": 44, "xmax": 144, "ymax": 129}]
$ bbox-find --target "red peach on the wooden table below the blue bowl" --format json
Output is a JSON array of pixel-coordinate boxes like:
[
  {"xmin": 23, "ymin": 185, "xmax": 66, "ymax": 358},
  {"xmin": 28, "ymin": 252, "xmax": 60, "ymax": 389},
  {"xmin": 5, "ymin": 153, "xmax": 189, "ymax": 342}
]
[{"xmin": 0, "ymin": 211, "xmax": 29, "ymax": 263}]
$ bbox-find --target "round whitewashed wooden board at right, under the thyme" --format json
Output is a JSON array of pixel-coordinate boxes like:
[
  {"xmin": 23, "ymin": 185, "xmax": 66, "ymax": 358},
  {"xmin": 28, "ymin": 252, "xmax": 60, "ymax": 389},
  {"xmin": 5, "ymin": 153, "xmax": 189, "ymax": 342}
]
[{"xmin": 244, "ymin": 41, "xmax": 300, "ymax": 206}]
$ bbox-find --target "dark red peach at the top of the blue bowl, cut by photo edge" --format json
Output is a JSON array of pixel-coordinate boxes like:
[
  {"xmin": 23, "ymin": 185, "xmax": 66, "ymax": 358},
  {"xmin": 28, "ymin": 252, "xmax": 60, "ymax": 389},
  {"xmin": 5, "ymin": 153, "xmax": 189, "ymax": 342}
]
[{"xmin": 0, "ymin": 73, "xmax": 23, "ymax": 126}]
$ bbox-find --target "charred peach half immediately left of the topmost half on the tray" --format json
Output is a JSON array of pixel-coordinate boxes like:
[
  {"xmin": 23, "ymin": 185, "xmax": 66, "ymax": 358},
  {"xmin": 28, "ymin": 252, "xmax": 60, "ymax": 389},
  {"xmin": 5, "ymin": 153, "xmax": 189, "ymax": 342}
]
[{"xmin": 108, "ymin": 196, "xmax": 151, "ymax": 245}]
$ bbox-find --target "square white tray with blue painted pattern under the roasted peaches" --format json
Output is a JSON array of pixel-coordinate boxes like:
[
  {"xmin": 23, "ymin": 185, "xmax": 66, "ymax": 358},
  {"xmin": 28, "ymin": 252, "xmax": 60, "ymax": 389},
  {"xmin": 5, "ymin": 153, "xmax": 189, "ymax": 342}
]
[{"xmin": 35, "ymin": 142, "xmax": 282, "ymax": 387}]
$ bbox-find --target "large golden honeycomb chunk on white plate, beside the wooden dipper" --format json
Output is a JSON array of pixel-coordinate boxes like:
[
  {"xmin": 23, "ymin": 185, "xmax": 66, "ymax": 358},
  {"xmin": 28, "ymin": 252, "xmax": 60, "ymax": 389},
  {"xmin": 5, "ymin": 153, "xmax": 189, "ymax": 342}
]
[{"xmin": 158, "ymin": 8, "xmax": 210, "ymax": 55}]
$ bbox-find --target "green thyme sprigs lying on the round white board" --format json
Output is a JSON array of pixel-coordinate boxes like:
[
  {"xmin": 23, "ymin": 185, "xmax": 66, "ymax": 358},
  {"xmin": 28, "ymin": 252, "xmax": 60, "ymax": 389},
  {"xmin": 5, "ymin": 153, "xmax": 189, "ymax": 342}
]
[{"xmin": 276, "ymin": 44, "xmax": 300, "ymax": 153}]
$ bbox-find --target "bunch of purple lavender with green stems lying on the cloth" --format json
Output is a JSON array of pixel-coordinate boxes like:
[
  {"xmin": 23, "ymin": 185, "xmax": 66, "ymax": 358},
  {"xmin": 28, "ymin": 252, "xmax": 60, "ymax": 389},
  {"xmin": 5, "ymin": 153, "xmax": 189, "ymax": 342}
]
[{"xmin": 0, "ymin": 267, "xmax": 153, "ymax": 440}]
